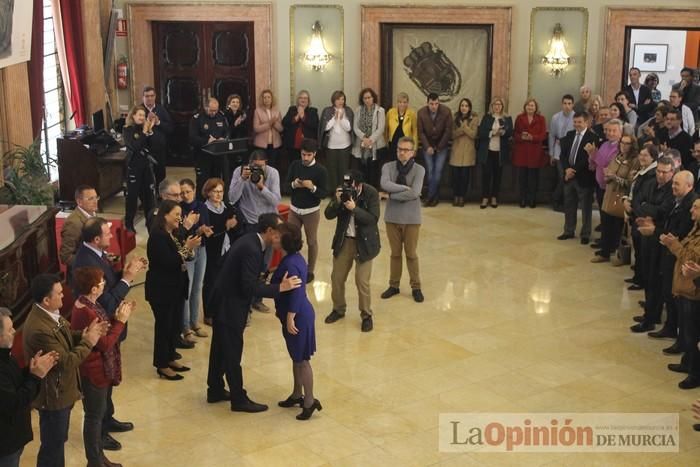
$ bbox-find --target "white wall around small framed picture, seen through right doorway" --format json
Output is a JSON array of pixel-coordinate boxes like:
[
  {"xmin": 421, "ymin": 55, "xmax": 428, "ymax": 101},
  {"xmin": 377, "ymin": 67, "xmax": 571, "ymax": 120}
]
[{"xmin": 630, "ymin": 29, "xmax": 687, "ymax": 99}]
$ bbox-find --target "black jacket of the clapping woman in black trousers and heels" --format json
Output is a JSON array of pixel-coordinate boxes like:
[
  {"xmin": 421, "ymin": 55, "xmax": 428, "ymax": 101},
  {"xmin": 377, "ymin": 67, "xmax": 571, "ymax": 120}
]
[{"xmin": 146, "ymin": 227, "xmax": 189, "ymax": 304}]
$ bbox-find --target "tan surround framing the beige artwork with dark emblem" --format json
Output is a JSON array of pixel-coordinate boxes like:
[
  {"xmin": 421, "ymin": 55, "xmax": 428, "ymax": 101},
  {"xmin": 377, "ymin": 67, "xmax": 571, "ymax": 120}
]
[{"xmin": 361, "ymin": 5, "xmax": 512, "ymax": 109}]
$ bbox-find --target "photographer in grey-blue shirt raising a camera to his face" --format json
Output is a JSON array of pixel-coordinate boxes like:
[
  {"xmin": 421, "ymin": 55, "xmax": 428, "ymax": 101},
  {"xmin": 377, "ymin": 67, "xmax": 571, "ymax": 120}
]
[{"xmin": 228, "ymin": 149, "xmax": 282, "ymax": 313}]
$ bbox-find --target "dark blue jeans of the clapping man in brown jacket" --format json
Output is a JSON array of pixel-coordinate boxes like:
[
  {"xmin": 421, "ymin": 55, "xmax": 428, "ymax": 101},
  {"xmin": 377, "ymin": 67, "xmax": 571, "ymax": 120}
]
[{"xmin": 36, "ymin": 405, "xmax": 73, "ymax": 467}]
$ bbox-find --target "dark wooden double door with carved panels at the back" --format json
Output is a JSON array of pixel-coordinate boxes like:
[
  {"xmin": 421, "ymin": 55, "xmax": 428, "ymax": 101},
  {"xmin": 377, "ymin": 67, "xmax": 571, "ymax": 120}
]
[{"xmin": 153, "ymin": 21, "xmax": 255, "ymax": 165}]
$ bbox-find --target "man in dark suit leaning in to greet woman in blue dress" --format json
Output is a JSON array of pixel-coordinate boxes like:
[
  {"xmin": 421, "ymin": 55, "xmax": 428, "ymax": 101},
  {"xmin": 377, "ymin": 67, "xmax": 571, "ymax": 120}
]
[{"xmin": 207, "ymin": 213, "xmax": 301, "ymax": 413}]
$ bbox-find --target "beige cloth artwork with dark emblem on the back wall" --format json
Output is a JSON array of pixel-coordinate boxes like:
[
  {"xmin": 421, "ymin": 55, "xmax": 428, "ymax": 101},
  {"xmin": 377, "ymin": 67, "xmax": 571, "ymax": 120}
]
[{"xmin": 380, "ymin": 23, "xmax": 493, "ymax": 114}]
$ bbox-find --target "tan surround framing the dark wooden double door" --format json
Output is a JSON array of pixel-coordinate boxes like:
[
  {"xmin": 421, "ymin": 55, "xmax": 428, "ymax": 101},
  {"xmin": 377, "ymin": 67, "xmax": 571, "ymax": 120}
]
[{"xmin": 127, "ymin": 3, "xmax": 273, "ymax": 108}]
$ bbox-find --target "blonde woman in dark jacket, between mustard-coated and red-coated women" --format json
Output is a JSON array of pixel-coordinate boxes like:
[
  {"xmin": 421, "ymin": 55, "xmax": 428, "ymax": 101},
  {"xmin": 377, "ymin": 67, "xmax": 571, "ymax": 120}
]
[{"xmin": 476, "ymin": 97, "xmax": 513, "ymax": 209}]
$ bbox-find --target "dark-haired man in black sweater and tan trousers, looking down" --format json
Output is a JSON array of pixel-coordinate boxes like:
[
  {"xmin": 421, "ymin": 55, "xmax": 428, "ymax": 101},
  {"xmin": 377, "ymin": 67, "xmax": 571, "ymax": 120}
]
[{"xmin": 287, "ymin": 138, "xmax": 328, "ymax": 282}]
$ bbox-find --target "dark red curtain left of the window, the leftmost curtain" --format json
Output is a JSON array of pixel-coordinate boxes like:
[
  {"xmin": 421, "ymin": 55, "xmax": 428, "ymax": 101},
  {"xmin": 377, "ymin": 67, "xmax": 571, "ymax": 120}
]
[{"xmin": 29, "ymin": 0, "xmax": 44, "ymax": 139}]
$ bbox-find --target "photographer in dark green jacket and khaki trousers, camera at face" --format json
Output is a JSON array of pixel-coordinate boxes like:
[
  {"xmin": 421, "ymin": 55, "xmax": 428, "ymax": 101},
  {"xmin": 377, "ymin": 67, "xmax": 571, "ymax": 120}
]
[{"xmin": 324, "ymin": 170, "xmax": 380, "ymax": 332}]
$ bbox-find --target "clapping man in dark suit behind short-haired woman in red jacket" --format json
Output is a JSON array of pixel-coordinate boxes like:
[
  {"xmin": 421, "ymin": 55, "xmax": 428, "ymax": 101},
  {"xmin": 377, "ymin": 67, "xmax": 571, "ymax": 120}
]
[{"xmin": 73, "ymin": 217, "xmax": 148, "ymax": 451}]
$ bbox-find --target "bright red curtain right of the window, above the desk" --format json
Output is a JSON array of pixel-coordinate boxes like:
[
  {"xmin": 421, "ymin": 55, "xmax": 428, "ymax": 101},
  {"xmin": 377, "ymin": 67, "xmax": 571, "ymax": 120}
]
[{"xmin": 54, "ymin": 0, "xmax": 87, "ymax": 127}]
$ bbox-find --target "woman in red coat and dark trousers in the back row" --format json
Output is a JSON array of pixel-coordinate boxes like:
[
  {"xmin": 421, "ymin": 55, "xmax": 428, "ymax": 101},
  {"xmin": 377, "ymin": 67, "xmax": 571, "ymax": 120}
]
[{"xmin": 513, "ymin": 99, "xmax": 547, "ymax": 208}]
